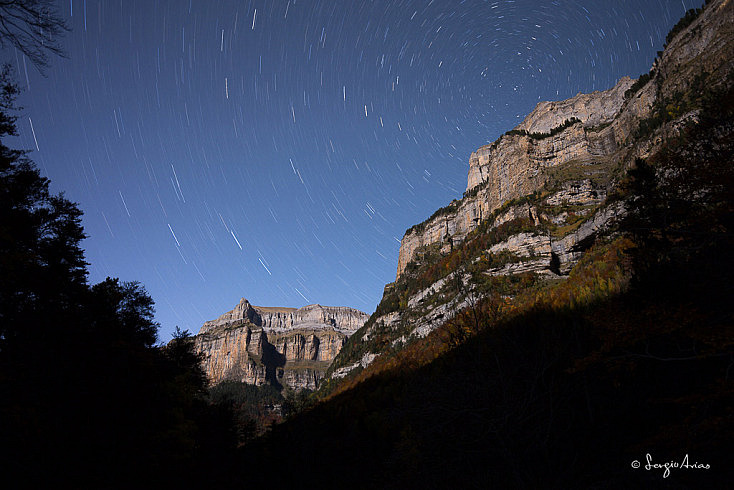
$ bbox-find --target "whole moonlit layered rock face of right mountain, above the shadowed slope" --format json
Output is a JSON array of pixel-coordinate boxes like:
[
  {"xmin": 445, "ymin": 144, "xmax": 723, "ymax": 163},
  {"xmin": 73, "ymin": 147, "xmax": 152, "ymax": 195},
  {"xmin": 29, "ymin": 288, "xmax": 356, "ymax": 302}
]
[{"xmin": 329, "ymin": 0, "xmax": 734, "ymax": 385}]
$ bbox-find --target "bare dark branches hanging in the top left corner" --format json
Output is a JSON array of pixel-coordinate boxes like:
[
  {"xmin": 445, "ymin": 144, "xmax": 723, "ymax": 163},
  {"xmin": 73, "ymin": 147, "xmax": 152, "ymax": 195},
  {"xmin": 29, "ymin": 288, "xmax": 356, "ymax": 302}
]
[{"xmin": 0, "ymin": 0, "xmax": 69, "ymax": 72}]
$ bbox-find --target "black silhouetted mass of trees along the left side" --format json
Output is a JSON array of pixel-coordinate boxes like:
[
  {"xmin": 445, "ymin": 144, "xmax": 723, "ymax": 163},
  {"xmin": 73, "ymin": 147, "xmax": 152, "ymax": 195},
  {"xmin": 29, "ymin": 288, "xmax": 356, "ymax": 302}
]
[{"xmin": 0, "ymin": 66, "xmax": 235, "ymax": 488}]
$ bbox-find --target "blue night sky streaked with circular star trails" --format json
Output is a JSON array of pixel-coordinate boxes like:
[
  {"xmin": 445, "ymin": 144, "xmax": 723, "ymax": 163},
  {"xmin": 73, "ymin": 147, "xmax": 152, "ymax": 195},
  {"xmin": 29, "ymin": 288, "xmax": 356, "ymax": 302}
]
[{"xmin": 3, "ymin": 0, "xmax": 703, "ymax": 342}]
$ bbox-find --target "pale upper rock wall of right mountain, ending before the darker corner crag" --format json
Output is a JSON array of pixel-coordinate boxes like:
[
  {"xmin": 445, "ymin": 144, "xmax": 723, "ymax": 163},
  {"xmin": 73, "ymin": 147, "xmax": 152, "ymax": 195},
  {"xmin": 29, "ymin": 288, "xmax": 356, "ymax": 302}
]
[{"xmin": 397, "ymin": 77, "xmax": 636, "ymax": 278}]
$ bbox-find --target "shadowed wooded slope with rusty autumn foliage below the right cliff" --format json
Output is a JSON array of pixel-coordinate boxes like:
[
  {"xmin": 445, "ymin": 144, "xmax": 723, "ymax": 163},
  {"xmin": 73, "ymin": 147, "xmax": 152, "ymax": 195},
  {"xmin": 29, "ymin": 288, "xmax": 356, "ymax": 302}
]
[{"xmin": 243, "ymin": 86, "xmax": 734, "ymax": 488}]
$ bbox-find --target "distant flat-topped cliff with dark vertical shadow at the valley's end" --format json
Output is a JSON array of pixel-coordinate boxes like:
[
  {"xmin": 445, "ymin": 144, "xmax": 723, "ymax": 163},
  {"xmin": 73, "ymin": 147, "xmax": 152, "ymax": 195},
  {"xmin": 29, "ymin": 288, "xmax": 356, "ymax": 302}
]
[{"xmin": 195, "ymin": 298, "xmax": 367, "ymax": 389}]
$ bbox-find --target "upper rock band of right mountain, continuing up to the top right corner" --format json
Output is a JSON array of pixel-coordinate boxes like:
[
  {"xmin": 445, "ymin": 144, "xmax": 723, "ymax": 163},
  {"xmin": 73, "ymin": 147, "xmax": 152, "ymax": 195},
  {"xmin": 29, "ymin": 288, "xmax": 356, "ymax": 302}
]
[{"xmin": 396, "ymin": 0, "xmax": 734, "ymax": 279}]
